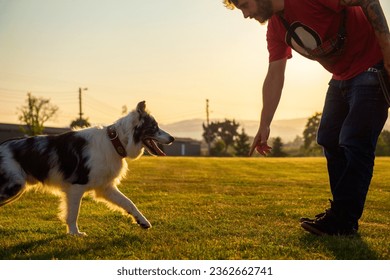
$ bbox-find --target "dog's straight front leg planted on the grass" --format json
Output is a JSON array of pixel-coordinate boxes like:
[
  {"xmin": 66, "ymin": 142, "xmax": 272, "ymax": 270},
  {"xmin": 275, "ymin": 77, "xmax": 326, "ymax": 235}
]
[{"xmin": 62, "ymin": 185, "xmax": 86, "ymax": 236}]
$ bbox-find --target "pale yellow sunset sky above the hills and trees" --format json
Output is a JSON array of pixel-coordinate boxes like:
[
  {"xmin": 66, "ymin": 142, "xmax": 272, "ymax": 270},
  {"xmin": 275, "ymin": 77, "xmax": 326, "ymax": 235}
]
[{"xmin": 0, "ymin": 0, "xmax": 390, "ymax": 127}]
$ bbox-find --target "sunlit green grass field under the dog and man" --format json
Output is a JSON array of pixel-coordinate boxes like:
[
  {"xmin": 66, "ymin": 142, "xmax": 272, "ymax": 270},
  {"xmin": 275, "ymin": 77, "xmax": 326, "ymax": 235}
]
[{"xmin": 0, "ymin": 157, "xmax": 390, "ymax": 260}]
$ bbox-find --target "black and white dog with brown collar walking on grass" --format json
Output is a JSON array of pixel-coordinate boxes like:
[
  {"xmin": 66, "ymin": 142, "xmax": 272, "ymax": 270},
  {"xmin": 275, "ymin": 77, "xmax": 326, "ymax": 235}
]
[{"xmin": 0, "ymin": 101, "xmax": 174, "ymax": 235}]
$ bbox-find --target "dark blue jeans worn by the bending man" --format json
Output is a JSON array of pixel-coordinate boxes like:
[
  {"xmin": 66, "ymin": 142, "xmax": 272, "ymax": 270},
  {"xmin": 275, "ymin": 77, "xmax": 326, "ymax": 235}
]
[{"xmin": 317, "ymin": 64, "xmax": 388, "ymax": 224}]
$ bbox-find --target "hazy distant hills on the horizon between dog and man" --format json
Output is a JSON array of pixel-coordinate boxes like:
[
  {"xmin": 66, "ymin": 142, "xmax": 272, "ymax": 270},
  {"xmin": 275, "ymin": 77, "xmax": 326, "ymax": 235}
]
[{"xmin": 160, "ymin": 118, "xmax": 307, "ymax": 142}]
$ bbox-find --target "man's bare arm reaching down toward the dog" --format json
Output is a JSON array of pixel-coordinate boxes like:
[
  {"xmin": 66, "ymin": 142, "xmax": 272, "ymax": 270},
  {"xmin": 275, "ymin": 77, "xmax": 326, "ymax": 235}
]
[{"xmin": 249, "ymin": 59, "xmax": 287, "ymax": 156}]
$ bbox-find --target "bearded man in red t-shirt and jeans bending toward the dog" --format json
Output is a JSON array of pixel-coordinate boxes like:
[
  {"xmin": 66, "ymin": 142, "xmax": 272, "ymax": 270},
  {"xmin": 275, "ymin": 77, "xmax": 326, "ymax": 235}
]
[{"xmin": 224, "ymin": 0, "xmax": 390, "ymax": 235}]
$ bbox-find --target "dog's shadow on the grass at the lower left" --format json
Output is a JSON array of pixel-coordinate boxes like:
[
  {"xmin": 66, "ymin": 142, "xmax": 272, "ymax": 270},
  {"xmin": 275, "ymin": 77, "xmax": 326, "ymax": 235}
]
[{"xmin": 0, "ymin": 228, "xmax": 143, "ymax": 260}]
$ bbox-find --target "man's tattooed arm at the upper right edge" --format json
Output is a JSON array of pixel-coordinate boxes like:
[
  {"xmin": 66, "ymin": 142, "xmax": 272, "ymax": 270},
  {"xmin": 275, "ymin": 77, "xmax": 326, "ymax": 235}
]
[{"xmin": 340, "ymin": 0, "xmax": 390, "ymax": 74}]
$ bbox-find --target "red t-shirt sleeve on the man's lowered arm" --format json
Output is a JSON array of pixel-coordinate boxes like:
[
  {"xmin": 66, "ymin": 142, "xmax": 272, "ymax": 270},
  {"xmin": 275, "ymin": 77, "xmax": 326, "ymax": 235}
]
[{"xmin": 267, "ymin": 16, "xmax": 292, "ymax": 62}]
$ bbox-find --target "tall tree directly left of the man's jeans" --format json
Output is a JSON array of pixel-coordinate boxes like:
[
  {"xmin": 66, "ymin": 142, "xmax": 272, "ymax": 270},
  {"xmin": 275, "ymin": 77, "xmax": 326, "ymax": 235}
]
[{"xmin": 303, "ymin": 112, "xmax": 322, "ymax": 155}]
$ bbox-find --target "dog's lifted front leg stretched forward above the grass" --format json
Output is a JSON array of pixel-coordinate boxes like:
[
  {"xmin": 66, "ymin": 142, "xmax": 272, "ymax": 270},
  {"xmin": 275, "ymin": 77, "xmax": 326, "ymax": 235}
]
[{"xmin": 96, "ymin": 186, "xmax": 152, "ymax": 229}]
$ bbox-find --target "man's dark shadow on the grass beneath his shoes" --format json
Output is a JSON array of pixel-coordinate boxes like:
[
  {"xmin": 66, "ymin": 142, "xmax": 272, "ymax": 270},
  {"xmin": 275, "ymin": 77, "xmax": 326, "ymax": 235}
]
[{"xmin": 300, "ymin": 233, "xmax": 380, "ymax": 260}]
